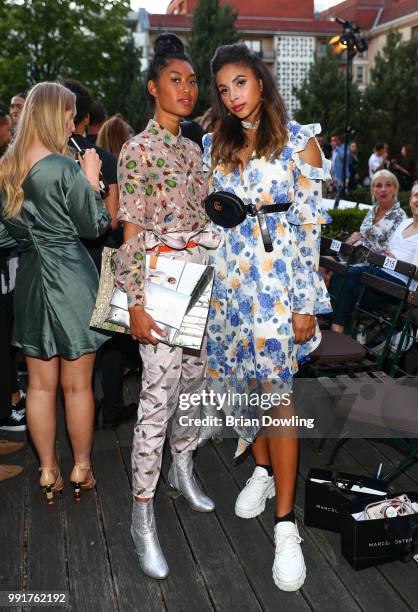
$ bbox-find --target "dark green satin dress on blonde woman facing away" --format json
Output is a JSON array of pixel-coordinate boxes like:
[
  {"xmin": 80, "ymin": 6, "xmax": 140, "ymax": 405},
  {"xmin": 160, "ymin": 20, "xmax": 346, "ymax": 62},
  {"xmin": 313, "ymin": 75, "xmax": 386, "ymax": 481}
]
[{"xmin": 0, "ymin": 153, "xmax": 110, "ymax": 359}]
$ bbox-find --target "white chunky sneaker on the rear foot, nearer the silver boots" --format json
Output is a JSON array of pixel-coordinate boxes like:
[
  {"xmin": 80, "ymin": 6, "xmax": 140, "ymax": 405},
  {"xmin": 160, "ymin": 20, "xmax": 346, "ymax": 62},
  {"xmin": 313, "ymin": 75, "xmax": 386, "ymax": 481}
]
[{"xmin": 235, "ymin": 466, "xmax": 276, "ymax": 518}]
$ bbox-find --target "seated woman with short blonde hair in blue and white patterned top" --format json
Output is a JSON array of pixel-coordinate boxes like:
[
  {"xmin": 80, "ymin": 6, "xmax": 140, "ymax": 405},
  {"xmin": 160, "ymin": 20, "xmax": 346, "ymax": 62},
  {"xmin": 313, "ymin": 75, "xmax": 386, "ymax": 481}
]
[{"xmin": 346, "ymin": 170, "xmax": 407, "ymax": 253}]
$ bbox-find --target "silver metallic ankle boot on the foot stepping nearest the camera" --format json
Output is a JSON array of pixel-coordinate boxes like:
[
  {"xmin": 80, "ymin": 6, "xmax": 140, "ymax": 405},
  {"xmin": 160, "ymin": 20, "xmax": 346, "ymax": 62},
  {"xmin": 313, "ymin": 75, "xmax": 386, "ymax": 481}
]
[{"xmin": 131, "ymin": 499, "xmax": 168, "ymax": 580}]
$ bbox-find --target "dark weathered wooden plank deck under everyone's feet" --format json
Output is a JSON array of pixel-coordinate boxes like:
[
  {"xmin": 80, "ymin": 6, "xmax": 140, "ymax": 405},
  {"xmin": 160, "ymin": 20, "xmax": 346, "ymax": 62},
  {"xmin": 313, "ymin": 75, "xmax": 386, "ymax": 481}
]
[{"xmin": 0, "ymin": 394, "xmax": 418, "ymax": 612}]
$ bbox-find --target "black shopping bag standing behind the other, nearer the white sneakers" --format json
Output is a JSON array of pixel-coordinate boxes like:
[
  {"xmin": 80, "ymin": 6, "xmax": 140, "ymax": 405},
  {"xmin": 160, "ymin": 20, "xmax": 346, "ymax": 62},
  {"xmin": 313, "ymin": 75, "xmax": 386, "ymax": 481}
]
[{"xmin": 305, "ymin": 468, "xmax": 388, "ymax": 532}]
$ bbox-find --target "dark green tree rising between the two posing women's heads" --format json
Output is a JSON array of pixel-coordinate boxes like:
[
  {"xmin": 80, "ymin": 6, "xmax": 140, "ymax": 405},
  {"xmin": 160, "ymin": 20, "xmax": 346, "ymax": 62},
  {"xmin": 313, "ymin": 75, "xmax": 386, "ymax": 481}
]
[{"xmin": 188, "ymin": 0, "xmax": 240, "ymax": 115}]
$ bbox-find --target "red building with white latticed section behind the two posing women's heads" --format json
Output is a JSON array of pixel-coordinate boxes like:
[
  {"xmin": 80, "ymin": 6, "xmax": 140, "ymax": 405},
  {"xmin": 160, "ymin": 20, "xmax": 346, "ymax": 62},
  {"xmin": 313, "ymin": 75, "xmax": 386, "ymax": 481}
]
[{"xmin": 130, "ymin": 0, "xmax": 339, "ymax": 114}]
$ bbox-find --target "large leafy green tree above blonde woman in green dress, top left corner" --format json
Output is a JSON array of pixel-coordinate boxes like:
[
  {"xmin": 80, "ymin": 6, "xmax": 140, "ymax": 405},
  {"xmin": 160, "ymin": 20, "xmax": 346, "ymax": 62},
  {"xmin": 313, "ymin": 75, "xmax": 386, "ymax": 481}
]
[{"xmin": 0, "ymin": 0, "xmax": 149, "ymax": 129}]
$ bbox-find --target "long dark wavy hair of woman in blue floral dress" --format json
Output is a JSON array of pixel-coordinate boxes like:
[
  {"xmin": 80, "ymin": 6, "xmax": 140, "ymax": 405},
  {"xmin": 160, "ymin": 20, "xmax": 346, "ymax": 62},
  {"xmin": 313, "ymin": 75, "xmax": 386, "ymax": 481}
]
[{"xmin": 211, "ymin": 43, "xmax": 289, "ymax": 172}]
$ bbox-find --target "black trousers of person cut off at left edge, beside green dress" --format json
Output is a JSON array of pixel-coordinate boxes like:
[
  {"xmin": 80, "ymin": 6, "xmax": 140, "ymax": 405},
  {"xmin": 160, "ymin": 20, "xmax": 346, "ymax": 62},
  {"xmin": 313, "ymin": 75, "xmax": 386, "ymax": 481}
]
[{"xmin": 0, "ymin": 292, "xmax": 18, "ymax": 419}]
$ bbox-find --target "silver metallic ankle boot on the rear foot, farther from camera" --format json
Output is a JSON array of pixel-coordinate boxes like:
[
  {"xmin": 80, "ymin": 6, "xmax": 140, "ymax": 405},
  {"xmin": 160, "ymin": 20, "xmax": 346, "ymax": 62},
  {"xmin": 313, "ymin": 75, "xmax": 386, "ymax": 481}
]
[{"xmin": 168, "ymin": 451, "xmax": 215, "ymax": 512}]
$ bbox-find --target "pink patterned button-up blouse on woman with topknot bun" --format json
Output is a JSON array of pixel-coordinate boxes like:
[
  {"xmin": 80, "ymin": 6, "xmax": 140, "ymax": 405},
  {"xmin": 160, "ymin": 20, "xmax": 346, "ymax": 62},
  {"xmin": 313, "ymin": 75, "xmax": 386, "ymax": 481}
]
[{"xmin": 113, "ymin": 119, "xmax": 208, "ymax": 306}]
